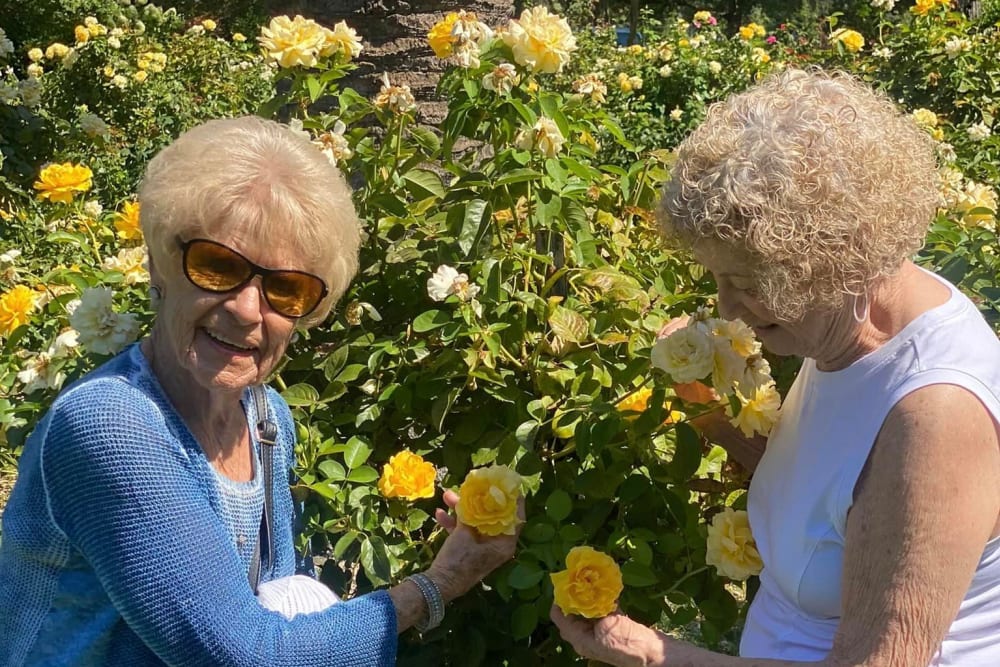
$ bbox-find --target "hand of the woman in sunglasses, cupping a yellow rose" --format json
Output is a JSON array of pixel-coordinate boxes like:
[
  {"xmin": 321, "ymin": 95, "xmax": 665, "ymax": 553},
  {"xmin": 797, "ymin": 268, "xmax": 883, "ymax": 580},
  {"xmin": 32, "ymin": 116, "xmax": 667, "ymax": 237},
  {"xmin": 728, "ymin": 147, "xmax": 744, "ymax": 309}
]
[{"xmin": 427, "ymin": 491, "xmax": 525, "ymax": 601}]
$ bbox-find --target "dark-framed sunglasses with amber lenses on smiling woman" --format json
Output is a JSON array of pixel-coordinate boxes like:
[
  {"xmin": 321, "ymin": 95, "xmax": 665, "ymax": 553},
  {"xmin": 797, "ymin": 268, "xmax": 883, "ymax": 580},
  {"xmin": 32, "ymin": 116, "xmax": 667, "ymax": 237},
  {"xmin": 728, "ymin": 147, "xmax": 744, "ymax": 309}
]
[{"xmin": 181, "ymin": 239, "xmax": 327, "ymax": 318}]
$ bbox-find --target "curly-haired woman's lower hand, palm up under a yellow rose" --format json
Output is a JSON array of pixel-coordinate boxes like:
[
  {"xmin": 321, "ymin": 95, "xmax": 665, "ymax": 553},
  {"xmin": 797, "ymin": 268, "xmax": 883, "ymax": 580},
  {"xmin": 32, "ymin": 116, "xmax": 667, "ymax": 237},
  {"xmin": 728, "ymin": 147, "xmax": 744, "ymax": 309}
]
[{"xmin": 549, "ymin": 605, "xmax": 667, "ymax": 667}]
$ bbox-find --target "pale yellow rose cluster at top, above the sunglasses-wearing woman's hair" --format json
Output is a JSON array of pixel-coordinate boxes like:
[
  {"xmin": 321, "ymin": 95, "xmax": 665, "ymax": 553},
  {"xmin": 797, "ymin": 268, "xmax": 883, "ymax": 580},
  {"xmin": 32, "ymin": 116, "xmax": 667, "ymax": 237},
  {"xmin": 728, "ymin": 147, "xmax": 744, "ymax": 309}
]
[{"xmin": 257, "ymin": 14, "xmax": 362, "ymax": 68}]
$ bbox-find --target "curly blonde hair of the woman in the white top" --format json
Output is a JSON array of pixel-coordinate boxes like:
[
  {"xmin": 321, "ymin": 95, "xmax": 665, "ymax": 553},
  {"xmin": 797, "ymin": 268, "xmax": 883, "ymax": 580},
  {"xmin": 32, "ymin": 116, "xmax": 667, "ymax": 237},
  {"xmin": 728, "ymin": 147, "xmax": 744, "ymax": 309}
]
[{"xmin": 659, "ymin": 69, "xmax": 938, "ymax": 320}]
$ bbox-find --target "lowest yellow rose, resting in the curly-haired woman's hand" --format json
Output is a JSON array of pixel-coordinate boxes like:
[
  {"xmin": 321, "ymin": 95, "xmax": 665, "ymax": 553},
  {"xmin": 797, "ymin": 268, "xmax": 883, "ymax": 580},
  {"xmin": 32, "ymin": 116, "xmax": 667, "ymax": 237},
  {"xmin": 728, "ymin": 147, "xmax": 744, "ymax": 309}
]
[{"xmin": 549, "ymin": 547, "xmax": 625, "ymax": 618}]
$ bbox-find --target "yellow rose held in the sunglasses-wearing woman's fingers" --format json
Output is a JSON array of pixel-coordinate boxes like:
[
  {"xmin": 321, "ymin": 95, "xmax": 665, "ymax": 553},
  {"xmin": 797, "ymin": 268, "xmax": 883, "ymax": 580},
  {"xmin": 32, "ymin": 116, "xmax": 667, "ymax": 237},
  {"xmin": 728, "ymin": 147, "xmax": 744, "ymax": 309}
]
[{"xmin": 455, "ymin": 465, "xmax": 521, "ymax": 536}]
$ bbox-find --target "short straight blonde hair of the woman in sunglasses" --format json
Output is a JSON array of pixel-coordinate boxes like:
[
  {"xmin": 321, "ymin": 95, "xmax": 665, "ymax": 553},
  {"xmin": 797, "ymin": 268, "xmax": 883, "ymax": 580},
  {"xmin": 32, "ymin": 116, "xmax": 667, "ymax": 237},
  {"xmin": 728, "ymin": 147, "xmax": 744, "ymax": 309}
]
[{"xmin": 139, "ymin": 116, "xmax": 361, "ymax": 327}]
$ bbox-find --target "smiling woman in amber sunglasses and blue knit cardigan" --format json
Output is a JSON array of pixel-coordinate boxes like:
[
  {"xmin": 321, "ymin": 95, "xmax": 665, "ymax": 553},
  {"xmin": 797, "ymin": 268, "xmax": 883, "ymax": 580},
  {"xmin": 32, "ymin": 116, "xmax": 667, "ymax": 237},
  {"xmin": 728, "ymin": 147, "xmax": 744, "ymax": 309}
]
[{"xmin": 0, "ymin": 118, "xmax": 517, "ymax": 667}]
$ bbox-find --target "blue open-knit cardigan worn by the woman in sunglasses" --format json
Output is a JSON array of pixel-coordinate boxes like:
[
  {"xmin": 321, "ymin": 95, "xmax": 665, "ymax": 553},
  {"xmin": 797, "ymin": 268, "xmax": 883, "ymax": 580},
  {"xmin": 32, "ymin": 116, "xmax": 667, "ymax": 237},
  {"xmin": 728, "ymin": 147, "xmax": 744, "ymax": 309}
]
[{"xmin": 0, "ymin": 345, "xmax": 396, "ymax": 667}]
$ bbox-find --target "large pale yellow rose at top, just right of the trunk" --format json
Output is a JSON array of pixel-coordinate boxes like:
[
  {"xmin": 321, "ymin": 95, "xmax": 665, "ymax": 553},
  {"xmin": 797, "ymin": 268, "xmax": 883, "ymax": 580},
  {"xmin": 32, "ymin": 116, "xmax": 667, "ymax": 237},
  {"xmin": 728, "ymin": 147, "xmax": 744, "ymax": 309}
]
[{"xmin": 503, "ymin": 6, "xmax": 576, "ymax": 74}]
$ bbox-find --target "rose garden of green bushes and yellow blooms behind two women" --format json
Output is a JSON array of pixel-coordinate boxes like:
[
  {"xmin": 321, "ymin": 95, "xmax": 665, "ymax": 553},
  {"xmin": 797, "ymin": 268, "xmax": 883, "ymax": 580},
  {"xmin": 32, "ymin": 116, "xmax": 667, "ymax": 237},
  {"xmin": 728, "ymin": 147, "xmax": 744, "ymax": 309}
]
[{"xmin": 0, "ymin": 0, "xmax": 1000, "ymax": 665}]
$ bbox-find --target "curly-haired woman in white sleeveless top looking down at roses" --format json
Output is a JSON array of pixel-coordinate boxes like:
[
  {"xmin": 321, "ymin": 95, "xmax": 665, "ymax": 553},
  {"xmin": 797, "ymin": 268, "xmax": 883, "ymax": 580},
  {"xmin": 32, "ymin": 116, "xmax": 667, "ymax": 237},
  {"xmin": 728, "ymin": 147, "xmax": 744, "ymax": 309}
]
[{"xmin": 552, "ymin": 70, "xmax": 1000, "ymax": 667}]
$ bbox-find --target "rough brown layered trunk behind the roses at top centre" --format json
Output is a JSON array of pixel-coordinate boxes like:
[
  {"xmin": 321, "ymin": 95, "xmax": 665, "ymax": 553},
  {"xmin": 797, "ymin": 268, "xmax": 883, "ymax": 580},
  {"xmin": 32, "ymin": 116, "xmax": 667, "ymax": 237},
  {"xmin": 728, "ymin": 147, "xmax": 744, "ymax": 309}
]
[{"xmin": 276, "ymin": 0, "xmax": 514, "ymax": 124}]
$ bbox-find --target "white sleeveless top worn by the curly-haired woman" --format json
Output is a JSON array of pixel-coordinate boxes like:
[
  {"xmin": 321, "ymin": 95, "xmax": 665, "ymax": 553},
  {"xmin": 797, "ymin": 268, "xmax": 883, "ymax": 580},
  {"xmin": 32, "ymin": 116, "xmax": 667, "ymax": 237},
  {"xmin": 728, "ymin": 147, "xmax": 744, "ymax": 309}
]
[{"xmin": 740, "ymin": 268, "xmax": 1000, "ymax": 667}]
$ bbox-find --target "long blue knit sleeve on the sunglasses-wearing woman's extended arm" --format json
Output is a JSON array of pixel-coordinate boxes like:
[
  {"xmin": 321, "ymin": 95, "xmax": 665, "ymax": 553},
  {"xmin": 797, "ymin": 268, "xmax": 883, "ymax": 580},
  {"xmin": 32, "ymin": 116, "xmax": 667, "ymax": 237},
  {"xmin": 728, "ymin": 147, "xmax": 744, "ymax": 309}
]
[{"xmin": 42, "ymin": 378, "xmax": 396, "ymax": 667}]
